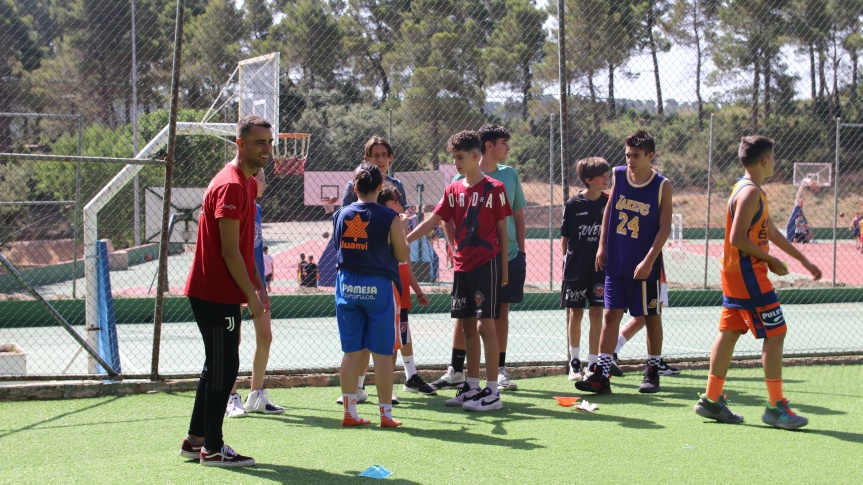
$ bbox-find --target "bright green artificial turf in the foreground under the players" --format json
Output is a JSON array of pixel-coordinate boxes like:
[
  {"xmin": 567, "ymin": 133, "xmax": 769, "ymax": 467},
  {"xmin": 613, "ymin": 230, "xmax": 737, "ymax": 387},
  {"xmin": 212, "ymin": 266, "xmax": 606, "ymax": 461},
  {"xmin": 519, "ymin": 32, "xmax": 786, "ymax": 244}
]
[{"xmin": 0, "ymin": 366, "xmax": 863, "ymax": 484}]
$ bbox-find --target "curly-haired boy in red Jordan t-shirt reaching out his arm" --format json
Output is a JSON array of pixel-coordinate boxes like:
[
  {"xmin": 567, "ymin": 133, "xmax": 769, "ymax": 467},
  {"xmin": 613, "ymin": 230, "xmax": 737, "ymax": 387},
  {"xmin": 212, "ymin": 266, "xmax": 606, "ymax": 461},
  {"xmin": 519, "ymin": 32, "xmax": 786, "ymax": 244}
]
[{"xmin": 408, "ymin": 131, "xmax": 512, "ymax": 411}]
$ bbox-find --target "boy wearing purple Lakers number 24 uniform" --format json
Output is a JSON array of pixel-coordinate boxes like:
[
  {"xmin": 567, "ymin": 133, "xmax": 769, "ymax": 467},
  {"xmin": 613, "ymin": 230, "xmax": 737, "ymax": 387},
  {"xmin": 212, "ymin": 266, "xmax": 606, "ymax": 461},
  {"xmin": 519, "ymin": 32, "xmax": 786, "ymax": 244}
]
[{"xmin": 575, "ymin": 130, "xmax": 672, "ymax": 394}]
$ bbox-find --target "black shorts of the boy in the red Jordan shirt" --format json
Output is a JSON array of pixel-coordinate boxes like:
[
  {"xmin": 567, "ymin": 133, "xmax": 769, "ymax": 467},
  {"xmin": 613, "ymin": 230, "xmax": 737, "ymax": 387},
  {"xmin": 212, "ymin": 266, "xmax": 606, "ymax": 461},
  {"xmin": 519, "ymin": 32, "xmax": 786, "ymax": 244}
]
[{"xmin": 450, "ymin": 254, "xmax": 501, "ymax": 318}]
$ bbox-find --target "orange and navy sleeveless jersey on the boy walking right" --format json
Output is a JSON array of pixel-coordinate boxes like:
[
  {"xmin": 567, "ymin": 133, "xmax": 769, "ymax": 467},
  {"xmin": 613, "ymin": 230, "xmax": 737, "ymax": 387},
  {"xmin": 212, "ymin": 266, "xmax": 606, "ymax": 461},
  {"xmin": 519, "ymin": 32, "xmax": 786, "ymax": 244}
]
[{"xmin": 721, "ymin": 178, "xmax": 777, "ymax": 308}]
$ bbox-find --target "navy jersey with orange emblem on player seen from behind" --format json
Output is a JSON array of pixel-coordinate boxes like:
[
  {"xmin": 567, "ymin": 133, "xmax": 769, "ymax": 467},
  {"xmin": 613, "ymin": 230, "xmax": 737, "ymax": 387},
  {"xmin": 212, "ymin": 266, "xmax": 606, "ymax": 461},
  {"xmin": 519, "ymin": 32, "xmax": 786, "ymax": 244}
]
[{"xmin": 333, "ymin": 202, "xmax": 401, "ymax": 292}]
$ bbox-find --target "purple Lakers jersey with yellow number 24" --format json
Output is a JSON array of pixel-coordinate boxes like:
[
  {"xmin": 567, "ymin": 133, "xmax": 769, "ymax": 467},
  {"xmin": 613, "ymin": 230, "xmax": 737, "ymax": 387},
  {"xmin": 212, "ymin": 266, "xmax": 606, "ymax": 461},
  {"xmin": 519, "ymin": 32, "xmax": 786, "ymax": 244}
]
[{"xmin": 605, "ymin": 166, "xmax": 666, "ymax": 280}]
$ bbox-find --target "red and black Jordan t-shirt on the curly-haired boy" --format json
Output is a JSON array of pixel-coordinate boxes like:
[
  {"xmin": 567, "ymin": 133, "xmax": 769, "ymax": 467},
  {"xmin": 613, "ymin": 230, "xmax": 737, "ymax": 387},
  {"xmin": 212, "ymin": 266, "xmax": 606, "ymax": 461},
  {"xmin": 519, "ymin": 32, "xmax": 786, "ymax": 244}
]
[{"xmin": 434, "ymin": 176, "xmax": 512, "ymax": 271}]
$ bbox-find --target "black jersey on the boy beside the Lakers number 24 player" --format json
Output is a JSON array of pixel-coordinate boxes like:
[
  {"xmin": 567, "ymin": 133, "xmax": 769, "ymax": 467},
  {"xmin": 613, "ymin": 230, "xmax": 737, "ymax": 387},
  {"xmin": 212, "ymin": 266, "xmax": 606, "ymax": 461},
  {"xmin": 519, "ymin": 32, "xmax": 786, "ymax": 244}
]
[{"xmin": 560, "ymin": 192, "xmax": 608, "ymax": 281}]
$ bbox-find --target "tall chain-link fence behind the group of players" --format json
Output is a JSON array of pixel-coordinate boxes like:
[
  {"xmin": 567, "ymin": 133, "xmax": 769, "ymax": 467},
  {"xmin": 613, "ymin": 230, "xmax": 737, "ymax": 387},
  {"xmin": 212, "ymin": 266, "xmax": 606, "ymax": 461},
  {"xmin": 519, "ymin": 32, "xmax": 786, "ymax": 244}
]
[{"xmin": 0, "ymin": 0, "xmax": 863, "ymax": 379}]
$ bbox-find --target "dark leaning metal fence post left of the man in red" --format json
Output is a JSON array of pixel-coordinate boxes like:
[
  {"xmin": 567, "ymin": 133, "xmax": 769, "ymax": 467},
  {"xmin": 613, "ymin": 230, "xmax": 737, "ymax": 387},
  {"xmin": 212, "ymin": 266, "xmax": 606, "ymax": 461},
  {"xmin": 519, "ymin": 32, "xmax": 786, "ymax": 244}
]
[{"xmin": 150, "ymin": 0, "xmax": 185, "ymax": 381}]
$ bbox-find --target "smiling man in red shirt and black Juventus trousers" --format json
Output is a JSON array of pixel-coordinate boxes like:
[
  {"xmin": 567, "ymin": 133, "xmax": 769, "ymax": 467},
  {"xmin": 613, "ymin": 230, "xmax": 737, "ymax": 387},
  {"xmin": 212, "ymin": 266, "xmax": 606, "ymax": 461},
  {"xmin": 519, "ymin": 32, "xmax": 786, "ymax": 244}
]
[{"xmin": 180, "ymin": 116, "xmax": 273, "ymax": 467}]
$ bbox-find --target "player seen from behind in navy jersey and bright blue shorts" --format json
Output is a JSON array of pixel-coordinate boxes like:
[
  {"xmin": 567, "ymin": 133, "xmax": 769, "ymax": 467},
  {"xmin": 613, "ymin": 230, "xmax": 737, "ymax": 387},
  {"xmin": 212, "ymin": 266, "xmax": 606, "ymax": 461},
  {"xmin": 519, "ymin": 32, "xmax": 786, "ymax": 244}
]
[{"xmin": 333, "ymin": 163, "xmax": 410, "ymax": 428}]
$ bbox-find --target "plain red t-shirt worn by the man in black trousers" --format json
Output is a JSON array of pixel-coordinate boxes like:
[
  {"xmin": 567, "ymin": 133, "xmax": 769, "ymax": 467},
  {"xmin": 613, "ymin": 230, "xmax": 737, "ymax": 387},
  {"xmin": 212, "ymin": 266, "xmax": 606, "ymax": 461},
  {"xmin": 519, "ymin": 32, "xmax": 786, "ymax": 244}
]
[{"xmin": 183, "ymin": 164, "xmax": 258, "ymax": 304}]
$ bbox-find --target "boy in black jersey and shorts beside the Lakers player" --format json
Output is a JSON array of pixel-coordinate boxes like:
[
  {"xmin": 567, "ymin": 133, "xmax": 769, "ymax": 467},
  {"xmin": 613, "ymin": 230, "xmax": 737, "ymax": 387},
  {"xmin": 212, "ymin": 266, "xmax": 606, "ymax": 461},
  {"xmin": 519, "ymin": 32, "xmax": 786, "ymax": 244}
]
[{"xmin": 560, "ymin": 157, "xmax": 611, "ymax": 381}]
